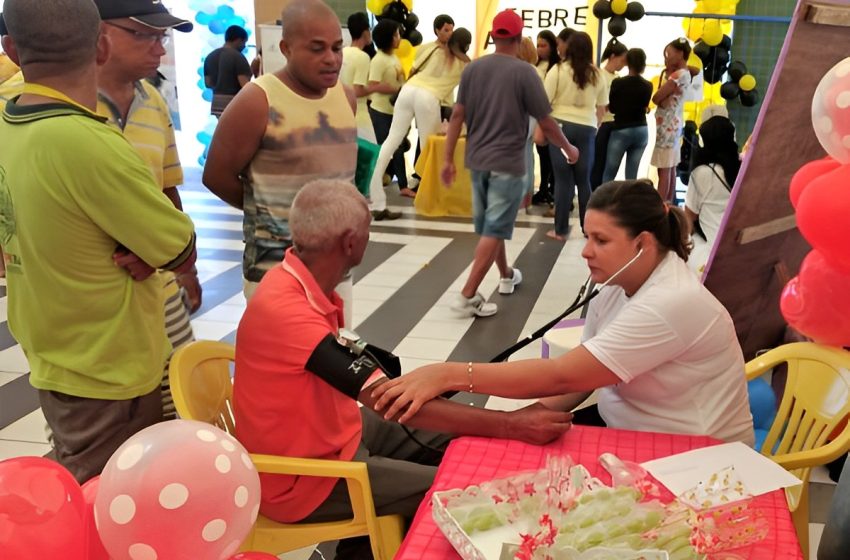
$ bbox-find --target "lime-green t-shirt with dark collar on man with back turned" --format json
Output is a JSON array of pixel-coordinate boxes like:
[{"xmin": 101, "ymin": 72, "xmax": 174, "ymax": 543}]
[{"xmin": 0, "ymin": 102, "xmax": 194, "ymax": 400}]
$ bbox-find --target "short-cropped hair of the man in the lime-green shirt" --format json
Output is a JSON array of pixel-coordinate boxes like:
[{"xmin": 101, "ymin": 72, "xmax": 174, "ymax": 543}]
[{"xmin": 3, "ymin": 0, "xmax": 100, "ymax": 69}]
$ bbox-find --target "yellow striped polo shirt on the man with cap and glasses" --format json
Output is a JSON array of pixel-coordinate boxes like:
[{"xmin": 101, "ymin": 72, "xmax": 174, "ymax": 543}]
[{"xmin": 97, "ymin": 80, "xmax": 183, "ymax": 189}]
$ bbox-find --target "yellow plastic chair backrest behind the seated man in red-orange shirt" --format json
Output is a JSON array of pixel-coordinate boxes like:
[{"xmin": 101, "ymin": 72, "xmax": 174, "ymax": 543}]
[{"xmin": 169, "ymin": 340, "xmax": 236, "ymax": 435}]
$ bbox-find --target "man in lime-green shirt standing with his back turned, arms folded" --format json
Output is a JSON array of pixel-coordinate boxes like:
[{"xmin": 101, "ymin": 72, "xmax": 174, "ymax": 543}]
[{"xmin": 0, "ymin": 0, "xmax": 195, "ymax": 482}]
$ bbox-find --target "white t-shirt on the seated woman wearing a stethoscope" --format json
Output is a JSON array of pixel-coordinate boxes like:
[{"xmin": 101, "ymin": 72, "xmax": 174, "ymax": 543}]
[{"xmin": 582, "ymin": 251, "xmax": 754, "ymax": 445}]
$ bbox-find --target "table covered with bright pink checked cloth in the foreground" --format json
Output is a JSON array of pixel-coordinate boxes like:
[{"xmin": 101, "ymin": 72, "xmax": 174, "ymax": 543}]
[{"xmin": 395, "ymin": 426, "xmax": 803, "ymax": 560}]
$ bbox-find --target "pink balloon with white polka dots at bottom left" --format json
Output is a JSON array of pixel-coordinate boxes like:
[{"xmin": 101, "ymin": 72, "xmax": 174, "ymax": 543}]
[{"xmin": 95, "ymin": 420, "xmax": 260, "ymax": 560}]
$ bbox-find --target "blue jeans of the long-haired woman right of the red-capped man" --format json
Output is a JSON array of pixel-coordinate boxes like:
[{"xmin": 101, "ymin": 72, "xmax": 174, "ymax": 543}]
[{"xmin": 549, "ymin": 122, "xmax": 596, "ymax": 236}]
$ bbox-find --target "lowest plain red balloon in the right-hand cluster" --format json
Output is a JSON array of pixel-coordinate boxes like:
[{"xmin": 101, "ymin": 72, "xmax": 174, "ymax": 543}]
[{"xmin": 779, "ymin": 250, "xmax": 850, "ymax": 346}]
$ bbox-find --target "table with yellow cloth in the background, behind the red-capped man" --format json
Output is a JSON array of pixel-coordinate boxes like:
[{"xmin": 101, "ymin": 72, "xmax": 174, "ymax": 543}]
[{"xmin": 413, "ymin": 134, "xmax": 472, "ymax": 217}]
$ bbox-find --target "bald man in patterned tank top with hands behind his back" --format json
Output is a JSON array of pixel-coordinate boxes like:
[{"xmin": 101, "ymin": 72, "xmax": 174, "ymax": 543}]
[{"xmin": 204, "ymin": 0, "xmax": 357, "ymax": 308}]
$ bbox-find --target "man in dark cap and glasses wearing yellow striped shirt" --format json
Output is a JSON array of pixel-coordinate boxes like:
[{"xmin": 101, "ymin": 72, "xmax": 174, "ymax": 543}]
[{"xmin": 95, "ymin": 0, "xmax": 201, "ymax": 419}]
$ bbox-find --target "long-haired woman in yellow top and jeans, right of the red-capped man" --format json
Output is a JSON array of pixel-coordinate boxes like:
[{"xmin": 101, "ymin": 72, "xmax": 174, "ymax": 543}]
[{"xmin": 543, "ymin": 31, "xmax": 608, "ymax": 241}]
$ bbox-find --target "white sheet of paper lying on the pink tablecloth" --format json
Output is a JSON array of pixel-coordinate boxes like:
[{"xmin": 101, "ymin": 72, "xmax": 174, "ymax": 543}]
[{"xmin": 641, "ymin": 442, "xmax": 802, "ymax": 496}]
